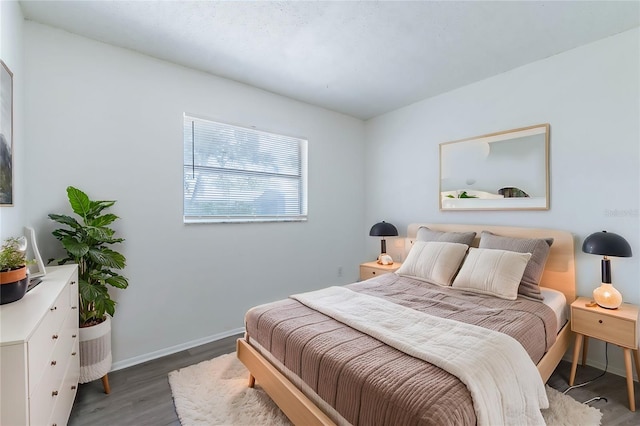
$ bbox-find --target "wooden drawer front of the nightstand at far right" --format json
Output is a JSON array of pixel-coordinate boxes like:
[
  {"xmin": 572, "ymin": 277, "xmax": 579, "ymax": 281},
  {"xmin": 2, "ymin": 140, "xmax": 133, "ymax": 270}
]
[{"xmin": 571, "ymin": 309, "xmax": 638, "ymax": 349}]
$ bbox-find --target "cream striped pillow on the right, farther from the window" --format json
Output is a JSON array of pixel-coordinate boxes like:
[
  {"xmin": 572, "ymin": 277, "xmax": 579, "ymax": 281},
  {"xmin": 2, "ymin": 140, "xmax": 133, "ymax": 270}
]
[{"xmin": 453, "ymin": 247, "xmax": 531, "ymax": 300}]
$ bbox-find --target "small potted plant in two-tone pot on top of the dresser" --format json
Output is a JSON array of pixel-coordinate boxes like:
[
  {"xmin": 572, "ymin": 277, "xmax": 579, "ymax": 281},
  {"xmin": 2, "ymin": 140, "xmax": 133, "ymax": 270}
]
[{"xmin": 0, "ymin": 237, "xmax": 30, "ymax": 305}]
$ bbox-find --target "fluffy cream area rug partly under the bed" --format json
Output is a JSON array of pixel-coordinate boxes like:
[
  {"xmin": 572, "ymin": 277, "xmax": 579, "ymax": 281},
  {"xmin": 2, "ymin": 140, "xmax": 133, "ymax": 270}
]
[{"xmin": 169, "ymin": 353, "xmax": 602, "ymax": 426}]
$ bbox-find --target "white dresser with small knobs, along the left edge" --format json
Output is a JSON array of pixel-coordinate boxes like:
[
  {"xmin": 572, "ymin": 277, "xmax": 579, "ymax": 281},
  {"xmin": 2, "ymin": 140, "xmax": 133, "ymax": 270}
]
[{"xmin": 0, "ymin": 265, "xmax": 80, "ymax": 426}]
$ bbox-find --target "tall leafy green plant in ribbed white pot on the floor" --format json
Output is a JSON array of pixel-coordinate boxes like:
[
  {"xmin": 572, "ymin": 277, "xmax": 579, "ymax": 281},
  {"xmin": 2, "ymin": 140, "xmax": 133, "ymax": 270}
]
[{"xmin": 49, "ymin": 186, "xmax": 129, "ymax": 393}]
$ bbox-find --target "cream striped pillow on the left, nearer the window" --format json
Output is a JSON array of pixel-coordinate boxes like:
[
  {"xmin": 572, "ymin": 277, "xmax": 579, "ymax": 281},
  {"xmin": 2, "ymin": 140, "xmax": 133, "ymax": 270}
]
[{"xmin": 396, "ymin": 241, "xmax": 469, "ymax": 286}]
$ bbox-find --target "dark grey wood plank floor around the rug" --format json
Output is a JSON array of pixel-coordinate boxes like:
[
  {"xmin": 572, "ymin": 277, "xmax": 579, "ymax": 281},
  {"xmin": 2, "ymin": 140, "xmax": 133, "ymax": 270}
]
[{"xmin": 69, "ymin": 336, "xmax": 640, "ymax": 426}]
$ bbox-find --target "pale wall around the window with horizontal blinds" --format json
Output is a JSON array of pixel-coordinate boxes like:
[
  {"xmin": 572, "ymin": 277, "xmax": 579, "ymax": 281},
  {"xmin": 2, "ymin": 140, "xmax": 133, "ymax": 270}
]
[{"xmin": 23, "ymin": 22, "xmax": 367, "ymax": 367}]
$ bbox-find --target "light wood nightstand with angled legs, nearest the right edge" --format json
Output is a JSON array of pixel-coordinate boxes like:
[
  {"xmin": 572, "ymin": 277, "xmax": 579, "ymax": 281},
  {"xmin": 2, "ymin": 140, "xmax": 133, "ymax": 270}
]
[{"xmin": 569, "ymin": 297, "xmax": 640, "ymax": 411}]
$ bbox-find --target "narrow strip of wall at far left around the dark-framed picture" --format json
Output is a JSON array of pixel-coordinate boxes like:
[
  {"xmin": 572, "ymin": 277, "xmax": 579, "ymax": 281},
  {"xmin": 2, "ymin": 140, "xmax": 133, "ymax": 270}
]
[{"xmin": 0, "ymin": 1, "xmax": 26, "ymax": 242}]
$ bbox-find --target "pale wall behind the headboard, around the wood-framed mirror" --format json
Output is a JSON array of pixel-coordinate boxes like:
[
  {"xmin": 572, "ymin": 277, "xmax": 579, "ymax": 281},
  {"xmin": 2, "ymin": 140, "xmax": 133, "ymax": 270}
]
[{"xmin": 365, "ymin": 29, "xmax": 640, "ymax": 372}]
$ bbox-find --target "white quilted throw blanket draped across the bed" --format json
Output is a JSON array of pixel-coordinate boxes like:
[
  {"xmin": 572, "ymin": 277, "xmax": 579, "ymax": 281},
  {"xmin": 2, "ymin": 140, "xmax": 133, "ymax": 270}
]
[{"xmin": 291, "ymin": 287, "xmax": 549, "ymax": 426}]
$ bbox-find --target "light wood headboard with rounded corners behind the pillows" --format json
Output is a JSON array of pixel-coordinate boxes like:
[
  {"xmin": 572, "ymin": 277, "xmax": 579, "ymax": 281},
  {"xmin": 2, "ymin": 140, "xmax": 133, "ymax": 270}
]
[{"xmin": 407, "ymin": 223, "xmax": 576, "ymax": 303}]
